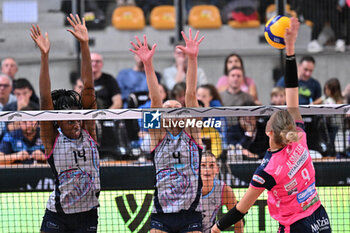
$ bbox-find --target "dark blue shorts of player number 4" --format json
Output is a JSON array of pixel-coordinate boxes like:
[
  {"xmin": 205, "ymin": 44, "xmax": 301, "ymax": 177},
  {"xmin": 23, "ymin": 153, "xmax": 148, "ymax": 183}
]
[{"xmin": 150, "ymin": 211, "xmax": 202, "ymax": 233}]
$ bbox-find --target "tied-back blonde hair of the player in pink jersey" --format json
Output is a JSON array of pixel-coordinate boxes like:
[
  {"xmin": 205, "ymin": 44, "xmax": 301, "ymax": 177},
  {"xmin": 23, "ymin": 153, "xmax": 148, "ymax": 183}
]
[{"xmin": 271, "ymin": 110, "xmax": 300, "ymax": 146}]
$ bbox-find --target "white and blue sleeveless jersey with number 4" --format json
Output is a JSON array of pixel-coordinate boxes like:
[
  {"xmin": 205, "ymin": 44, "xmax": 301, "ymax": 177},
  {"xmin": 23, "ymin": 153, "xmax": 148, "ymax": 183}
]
[{"xmin": 152, "ymin": 130, "xmax": 202, "ymax": 213}]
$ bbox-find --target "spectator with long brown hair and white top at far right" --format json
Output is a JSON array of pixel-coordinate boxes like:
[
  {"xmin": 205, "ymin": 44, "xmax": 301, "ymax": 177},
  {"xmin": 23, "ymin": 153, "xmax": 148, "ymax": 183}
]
[{"xmin": 323, "ymin": 78, "xmax": 344, "ymax": 104}]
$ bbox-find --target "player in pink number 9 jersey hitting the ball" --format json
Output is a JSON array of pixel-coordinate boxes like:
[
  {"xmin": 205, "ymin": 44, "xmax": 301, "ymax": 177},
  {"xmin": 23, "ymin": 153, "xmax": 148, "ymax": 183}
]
[{"xmin": 211, "ymin": 18, "xmax": 331, "ymax": 233}]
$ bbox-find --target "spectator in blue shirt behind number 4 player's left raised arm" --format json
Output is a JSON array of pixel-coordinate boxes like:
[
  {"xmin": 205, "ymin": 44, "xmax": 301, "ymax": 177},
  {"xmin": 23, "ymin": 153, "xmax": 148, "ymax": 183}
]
[{"xmin": 116, "ymin": 46, "xmax": 161, "ymax": 108}]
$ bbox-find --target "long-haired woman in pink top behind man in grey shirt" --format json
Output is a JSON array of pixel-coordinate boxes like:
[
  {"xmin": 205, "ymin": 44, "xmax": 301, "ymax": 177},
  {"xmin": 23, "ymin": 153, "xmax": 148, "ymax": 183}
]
[{"xmin": 216, "ymin": 53, "xmax": 258, "ymax": 101}]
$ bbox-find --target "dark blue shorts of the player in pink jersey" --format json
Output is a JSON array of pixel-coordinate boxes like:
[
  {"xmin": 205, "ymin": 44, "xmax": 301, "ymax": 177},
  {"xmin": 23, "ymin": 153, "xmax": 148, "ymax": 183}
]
[{"xmin": 278, "ymin": 205, "xmax": 332, "ymax": 233}]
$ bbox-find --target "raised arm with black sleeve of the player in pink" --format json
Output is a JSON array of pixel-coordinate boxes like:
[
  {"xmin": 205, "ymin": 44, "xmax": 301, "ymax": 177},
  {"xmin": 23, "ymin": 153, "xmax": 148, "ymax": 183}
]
[{"xmin": 284, "ymin": 17, "xmax": 302, "ymax": 120}]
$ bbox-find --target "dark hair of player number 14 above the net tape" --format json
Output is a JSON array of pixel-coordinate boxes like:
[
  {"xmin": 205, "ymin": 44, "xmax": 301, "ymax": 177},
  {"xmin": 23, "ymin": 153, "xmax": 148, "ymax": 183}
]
[{"xmin": 51, "ymin": 89, "xmax": 83, "ymax": 110}]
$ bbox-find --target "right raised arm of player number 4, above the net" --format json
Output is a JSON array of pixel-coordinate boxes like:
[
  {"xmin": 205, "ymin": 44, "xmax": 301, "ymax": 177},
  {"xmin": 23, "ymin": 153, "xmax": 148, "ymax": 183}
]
[{"xmin": 177, "ymin": 28, "xmax": 204, "ymax": 107}]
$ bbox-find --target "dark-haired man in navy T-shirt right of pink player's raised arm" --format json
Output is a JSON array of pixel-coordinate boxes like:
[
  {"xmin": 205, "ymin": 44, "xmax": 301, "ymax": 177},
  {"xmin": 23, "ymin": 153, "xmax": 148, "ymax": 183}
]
[{"xmin": 276, "ymin": 56, "xmax": 322, "ymax": 105}]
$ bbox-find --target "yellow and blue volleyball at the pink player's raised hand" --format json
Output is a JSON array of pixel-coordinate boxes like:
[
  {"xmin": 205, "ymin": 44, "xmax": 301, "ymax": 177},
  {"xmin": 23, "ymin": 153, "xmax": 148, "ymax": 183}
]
[{"xmin": 264, "ymin": 15, "xmax": 290, "ymax": 49}]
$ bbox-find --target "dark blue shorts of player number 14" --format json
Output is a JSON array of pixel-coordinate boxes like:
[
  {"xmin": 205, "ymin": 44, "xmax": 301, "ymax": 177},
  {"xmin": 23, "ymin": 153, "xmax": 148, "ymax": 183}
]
[{"xmin": 40, "ymin": 209, "xmax": 98, "ymax": 233}]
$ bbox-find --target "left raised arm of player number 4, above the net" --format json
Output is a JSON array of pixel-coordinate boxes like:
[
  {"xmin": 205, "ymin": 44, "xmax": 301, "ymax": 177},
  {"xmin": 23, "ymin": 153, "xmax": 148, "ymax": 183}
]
[{"xmin": 130, "ymin": 35, "xmax": 163, "ymax": 108}]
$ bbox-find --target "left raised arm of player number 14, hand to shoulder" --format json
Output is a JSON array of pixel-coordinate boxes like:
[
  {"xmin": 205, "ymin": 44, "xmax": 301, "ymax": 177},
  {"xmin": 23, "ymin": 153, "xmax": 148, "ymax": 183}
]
[{"xmin": 30, "ymin": 25, "xmax": 57, "ymax": 154}]
